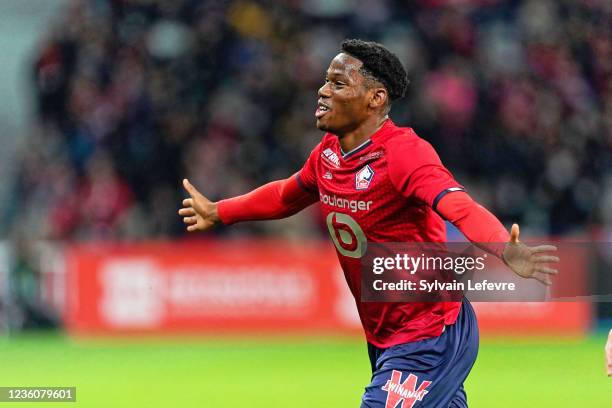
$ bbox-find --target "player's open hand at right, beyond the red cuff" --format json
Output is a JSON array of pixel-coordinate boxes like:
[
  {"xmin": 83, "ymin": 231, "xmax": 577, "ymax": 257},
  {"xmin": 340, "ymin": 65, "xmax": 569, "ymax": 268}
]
[{"xmin": 503, "ymin": 224, "xmax": 559, "ymax": 285}]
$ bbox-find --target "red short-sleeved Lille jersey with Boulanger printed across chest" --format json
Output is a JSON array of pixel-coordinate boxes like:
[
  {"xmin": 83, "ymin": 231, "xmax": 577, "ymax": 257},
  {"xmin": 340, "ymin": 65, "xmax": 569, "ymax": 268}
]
[{"xmin": 297, "ymin": 119, "xmax": 463, "ymax": 348}]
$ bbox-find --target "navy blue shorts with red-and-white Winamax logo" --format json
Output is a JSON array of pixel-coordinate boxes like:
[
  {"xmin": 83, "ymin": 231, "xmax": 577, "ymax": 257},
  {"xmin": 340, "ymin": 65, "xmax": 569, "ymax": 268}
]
[{"xmin": 361, "ymin": 300, "xmax": 478, "ymax": 408}]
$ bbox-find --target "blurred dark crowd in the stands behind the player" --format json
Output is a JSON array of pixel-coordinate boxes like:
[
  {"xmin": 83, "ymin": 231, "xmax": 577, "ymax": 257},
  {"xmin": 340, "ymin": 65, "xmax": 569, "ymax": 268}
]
[{"xmin": 0, "ymin": 0, "xmax": 612, "ymax": 240}]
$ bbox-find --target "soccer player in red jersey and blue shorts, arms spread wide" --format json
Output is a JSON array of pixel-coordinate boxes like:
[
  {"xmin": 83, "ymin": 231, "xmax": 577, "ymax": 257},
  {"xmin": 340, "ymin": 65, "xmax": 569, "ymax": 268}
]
[{"xmin": 179, "ymin": 40, "xmax": 558, "ymax": 408}]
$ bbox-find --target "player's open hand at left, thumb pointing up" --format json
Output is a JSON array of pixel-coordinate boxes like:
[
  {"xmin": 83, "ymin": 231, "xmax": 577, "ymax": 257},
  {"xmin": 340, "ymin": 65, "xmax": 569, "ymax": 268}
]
[{"xmin": 179, "ymin": 179, "xmax": 221, "ymax": 232}]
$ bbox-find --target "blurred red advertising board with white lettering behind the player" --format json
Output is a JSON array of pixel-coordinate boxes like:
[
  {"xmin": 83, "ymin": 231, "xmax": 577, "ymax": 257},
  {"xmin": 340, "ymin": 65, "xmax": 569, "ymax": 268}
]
[{"xmin": 65, "ymin": 240, "xmax": 591, "ymax": 335}]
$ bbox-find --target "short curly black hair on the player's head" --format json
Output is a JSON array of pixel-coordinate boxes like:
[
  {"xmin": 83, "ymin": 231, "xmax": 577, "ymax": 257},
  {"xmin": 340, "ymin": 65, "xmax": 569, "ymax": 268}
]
[{"xmin": 341, "ymin": 39, "xmax": 409, "ymax": 101}]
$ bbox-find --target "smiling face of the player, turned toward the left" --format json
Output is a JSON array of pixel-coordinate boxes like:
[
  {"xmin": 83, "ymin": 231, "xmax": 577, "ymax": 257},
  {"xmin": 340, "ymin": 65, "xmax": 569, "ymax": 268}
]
[{"xmin": 315, "ymin": 53, "xmax": 369, "ymax": 136}]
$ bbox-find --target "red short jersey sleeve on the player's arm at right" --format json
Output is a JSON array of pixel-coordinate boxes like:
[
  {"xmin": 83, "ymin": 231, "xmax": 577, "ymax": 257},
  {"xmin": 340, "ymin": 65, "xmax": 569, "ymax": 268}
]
[{"xmin": 387, "ymin": 136, "xmax": 464, "ymax": 210}]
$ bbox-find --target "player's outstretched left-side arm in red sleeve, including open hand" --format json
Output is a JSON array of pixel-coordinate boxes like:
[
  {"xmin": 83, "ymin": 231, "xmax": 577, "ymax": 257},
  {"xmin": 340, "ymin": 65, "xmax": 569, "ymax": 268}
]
[{"xmin": 179, "ymin": 176, "xmax": 319, "ymax": 232}]
